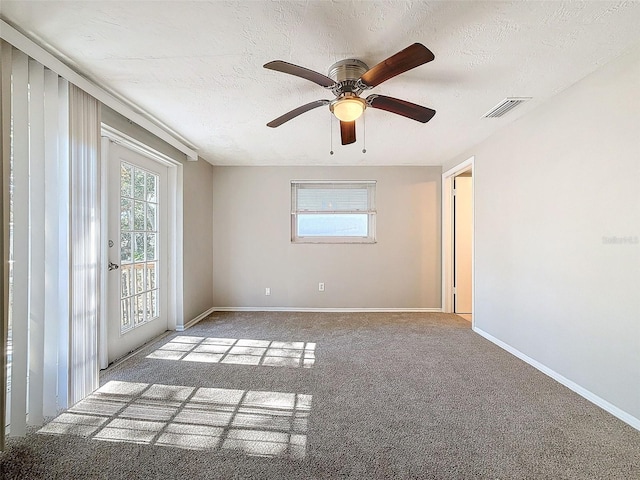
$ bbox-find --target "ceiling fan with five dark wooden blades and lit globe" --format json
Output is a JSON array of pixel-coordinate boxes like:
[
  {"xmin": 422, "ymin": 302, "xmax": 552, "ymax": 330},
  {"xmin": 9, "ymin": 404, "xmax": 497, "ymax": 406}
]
[{"xmin": 264, "ymin": 43, "xmax": 436, "ymax": 145}]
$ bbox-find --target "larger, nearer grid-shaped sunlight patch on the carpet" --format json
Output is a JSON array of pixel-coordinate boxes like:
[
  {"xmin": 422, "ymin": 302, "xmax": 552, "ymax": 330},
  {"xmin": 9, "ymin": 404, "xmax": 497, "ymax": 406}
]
[{"xmin": 38, "ymin": 381, "xmax": 312, "ymax": 459}]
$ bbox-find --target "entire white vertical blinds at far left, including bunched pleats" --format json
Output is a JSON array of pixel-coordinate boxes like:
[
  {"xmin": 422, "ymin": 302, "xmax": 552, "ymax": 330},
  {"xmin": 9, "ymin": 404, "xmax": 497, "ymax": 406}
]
[{"xmin": 0, "ymin": 42, "xmax": 100, "ymax": 446}]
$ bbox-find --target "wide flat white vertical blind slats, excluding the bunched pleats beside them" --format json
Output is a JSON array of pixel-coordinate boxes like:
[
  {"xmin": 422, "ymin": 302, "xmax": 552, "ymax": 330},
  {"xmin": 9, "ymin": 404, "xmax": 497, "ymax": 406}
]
[{"xmin": 2, "ymin": 44, "xmax": 69, "ymax": 436}]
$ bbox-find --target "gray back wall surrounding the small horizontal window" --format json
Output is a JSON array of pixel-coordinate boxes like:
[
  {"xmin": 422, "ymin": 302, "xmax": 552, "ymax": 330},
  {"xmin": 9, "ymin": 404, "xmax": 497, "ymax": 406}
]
[{"xmin": 213, "ymin": 167, "xmax": 441, "ymax": 308}]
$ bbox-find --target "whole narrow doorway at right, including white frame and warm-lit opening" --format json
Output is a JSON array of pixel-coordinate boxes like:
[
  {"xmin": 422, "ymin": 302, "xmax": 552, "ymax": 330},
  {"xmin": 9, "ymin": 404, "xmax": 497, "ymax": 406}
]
[{"xmin": 442, "ymin": 157, "xmax": 474, "ymax": 324}]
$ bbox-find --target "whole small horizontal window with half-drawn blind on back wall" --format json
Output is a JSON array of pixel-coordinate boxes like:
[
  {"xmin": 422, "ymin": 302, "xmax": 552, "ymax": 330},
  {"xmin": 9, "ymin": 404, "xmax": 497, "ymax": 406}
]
[{"xmin": 291, "ymin": 181, "xmax": 376, "ymax": 243}]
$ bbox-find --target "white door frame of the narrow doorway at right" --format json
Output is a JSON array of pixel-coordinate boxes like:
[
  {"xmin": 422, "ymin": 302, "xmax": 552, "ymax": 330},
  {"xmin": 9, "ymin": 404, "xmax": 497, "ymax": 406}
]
[{"xmin": 442, "ymin": 157, "xmax": 476, "ymax": 326}]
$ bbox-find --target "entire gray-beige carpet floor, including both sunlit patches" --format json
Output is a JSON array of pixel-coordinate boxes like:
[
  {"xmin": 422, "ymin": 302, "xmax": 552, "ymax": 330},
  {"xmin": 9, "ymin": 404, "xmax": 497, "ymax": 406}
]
[{"xmin": 0, "ymin": 313, "xmax": 640, "ymax": 480}]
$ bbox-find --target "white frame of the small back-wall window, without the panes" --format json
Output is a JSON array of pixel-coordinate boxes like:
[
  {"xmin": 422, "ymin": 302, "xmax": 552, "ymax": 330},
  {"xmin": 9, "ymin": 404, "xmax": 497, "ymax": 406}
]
[{"xmin": 291, "ymin": 180, "xmax": 377, "ymax": 243}]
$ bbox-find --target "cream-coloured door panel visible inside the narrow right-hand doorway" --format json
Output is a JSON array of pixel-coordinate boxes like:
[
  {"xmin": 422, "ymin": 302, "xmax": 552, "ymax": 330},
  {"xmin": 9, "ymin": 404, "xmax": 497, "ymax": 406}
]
[{"xmin": 453, "ymin": 176, "xmax": 473, "ymax": 313}]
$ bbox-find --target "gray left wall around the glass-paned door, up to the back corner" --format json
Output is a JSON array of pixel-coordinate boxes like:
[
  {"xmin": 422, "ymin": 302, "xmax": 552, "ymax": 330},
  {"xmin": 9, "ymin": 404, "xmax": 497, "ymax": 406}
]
[{"xmin": 102, "ymin": 106, "xmax": 213, "ymax": 324}]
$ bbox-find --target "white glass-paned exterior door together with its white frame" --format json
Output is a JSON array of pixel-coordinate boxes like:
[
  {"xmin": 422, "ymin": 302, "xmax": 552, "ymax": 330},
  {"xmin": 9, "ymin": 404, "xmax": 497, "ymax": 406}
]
[{"xmin": 98, "ymin": 124, "xmax": 184, "ymax": 369}]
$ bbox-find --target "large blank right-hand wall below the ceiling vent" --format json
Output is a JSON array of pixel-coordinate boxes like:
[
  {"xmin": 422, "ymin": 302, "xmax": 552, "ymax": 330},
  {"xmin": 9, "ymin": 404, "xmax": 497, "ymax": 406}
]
[{"xmin": 448, "ymin": 43, "xmax": 640, "ymax": 425}]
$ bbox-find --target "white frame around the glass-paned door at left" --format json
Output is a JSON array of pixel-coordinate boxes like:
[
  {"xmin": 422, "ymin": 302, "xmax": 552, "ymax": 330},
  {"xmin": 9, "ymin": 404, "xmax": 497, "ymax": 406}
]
[{"xmin": 98, "ymin": 123, "xmax": 184, "ymax": 368}]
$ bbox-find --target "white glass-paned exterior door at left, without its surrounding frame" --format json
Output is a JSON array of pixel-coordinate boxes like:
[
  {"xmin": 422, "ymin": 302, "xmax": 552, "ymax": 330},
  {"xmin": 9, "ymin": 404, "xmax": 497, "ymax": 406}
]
[{"xmin": 107, "ymin": 142, "xmax": 168, "ymax": 363}]
